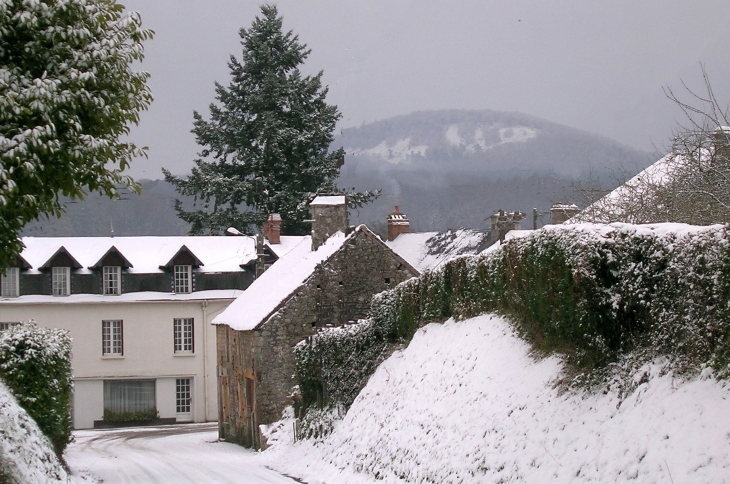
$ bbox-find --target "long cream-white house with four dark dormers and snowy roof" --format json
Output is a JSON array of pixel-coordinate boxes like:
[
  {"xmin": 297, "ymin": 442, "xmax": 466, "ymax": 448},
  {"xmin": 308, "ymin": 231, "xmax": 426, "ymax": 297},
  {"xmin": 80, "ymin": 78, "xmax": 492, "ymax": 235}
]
[{"xmin": 0, "ymin": 236, "xmax": 302, "ymax": 429}]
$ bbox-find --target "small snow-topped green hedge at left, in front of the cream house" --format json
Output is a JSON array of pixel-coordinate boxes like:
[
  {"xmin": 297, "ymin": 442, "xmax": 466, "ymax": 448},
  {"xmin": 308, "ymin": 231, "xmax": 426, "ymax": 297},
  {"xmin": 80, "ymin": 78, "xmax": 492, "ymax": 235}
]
[{"xmin": 0, "ymin": 323, "xmax": 73, "ymax": 456}]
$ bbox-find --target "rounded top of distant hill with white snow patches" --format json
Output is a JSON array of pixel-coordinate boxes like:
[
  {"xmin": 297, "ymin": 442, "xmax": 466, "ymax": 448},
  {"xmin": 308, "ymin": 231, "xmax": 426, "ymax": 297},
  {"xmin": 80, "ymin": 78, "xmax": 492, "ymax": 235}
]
[{"xmin": 334, "ymin": 110, "xmax": 656, "ymax": 177}]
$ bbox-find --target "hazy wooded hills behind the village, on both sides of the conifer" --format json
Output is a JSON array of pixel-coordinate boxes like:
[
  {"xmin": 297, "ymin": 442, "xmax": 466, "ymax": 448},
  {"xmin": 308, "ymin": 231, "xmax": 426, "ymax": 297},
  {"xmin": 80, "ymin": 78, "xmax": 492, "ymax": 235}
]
[{"xmin": 23, "ymin": 110, "xmax": 656, "ymax": 236}]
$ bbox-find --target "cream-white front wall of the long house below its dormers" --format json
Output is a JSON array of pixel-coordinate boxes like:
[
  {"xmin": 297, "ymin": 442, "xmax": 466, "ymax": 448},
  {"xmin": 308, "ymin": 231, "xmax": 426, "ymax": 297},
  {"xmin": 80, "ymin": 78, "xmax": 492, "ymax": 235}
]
[{"xmin": 0, "ymin": 290, "xmax": 233, "ymax": 429}]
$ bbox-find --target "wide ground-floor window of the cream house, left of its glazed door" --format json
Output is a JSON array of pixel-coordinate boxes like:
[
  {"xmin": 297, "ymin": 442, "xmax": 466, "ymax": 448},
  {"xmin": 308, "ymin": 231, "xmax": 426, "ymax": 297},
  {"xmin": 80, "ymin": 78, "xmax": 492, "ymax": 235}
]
[{"xmin": 104, "ymin": 380, "xmax": 157, "ymax": 420}]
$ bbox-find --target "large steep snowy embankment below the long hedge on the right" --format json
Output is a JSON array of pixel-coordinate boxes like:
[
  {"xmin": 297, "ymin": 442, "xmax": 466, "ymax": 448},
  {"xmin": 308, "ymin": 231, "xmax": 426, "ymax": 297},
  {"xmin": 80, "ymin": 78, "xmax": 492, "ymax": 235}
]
[{"xmin": 262, "ymin": 315, "xmax": 730, "ymax": 484}]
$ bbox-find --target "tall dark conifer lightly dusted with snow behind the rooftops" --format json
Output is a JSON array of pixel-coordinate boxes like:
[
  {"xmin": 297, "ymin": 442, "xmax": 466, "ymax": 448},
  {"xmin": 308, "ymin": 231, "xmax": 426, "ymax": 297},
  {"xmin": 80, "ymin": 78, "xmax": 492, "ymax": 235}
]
[{"xmin": 163, "ymin": 5, "xmax": 377, "ymax": 234}]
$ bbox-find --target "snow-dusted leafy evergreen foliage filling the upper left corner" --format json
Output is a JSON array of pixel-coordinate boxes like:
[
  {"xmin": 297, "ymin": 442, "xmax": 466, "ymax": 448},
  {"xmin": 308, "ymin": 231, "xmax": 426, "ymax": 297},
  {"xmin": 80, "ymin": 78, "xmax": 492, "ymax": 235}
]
[{"xmin": 0, "ymin": 0, "xmax": 153, "ymax": 271}]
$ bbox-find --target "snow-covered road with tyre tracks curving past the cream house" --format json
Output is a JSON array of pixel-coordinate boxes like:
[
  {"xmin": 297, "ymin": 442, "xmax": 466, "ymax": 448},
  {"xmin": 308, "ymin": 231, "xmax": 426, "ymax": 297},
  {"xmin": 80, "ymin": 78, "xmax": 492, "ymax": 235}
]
[{"xmin": 65, "ymin": 423, "xmax": 297, "ymax": 484}]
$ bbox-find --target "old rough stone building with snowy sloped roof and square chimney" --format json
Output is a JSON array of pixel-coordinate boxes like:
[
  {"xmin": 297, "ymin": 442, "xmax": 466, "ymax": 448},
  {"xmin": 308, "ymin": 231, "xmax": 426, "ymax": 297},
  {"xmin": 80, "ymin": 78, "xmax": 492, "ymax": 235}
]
[{"xmin": 213, "ymin": 197, "xmax": 418, "ymax": 448}]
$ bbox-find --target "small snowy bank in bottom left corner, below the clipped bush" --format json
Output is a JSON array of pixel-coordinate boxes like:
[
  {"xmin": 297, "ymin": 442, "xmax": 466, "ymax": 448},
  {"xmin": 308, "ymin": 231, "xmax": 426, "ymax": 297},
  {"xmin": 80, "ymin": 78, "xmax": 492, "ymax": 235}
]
[{"xmin": 0, "ymin": 380, "xmax": 69, "ymax": 484}]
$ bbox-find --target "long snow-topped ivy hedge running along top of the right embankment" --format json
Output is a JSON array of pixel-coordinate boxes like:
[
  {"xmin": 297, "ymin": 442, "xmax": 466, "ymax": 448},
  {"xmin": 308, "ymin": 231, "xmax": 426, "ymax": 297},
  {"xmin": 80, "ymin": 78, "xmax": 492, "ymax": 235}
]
[{"xmin": 297, "ymin": 224, "xmax": 730, "ymax": 416}]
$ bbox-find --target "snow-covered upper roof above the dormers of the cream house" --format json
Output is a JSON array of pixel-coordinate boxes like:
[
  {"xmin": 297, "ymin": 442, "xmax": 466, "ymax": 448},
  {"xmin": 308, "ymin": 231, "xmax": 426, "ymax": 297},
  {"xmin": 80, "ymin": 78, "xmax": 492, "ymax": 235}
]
[{"xmin": 15, "ymin": 236, "xmax": 302, "ymax": 274}]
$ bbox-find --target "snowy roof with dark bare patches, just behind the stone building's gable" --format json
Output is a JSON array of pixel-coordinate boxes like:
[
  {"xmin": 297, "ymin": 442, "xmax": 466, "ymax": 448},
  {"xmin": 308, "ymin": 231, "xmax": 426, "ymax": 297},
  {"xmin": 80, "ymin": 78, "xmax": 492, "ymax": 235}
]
[{"xmin": 386, "ymin": 229, "xmax": 487, "ymax": 272}]
